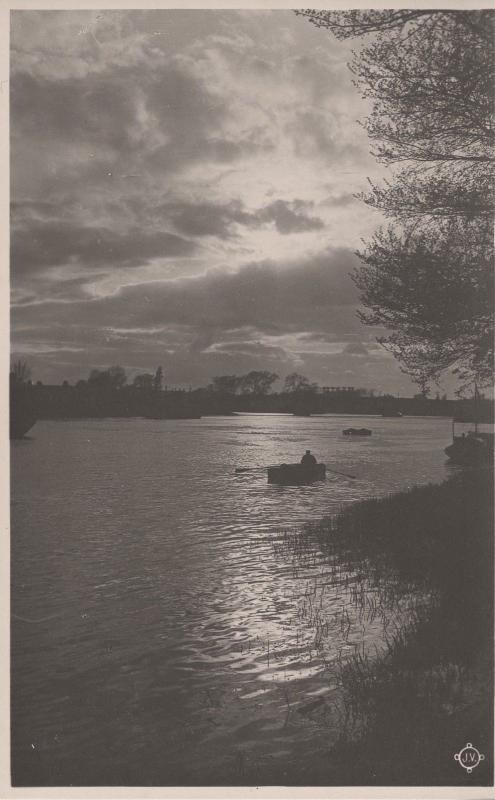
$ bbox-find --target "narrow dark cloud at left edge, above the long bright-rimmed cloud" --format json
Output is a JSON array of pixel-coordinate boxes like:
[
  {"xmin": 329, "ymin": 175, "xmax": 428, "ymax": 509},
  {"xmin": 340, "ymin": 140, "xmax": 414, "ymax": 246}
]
[{"xmin": 11, "ymin": 219, "xmax": 195, "ymax": 275}]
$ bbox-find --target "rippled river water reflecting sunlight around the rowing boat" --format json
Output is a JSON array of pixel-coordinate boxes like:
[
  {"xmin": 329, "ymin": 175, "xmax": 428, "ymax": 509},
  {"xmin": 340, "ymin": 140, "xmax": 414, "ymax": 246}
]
[{"xmin": 11, "ymin": 414, "xmax": 460, "ymax": 785}]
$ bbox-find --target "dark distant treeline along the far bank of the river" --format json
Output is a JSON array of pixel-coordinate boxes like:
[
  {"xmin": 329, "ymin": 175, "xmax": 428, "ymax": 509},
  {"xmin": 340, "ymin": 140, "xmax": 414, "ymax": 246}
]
[{"xmin": 11, "ymin": 362, "xmax": 493, "ymax": 422}]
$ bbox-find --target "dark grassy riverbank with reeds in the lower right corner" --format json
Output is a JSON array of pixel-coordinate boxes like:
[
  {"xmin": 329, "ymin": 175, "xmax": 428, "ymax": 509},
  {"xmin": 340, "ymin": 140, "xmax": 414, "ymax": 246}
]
[{"xmin": 280, "ymin": 470, "xmax": 493, "ymax": 785}]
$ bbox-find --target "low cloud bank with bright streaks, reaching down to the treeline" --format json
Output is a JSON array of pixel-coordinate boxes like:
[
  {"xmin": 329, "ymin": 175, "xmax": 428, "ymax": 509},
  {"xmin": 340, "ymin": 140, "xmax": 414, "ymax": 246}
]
[{"xmin": 9, "ymin": 249, "xmax": 414, "ymax": 388}]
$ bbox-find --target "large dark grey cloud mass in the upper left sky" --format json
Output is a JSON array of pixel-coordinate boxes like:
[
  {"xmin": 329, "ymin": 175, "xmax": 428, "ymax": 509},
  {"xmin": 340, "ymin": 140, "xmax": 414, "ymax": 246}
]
[{"xmin": 10, "ymin": 36, "xmax": 273, "ymax": 198}]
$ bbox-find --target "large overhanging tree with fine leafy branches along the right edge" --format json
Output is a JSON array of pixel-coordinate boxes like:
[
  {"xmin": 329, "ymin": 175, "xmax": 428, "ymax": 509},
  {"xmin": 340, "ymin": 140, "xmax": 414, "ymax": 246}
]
[{"xmin": 299, "ymin": 9, "xmax": 495, "ymax": 386}]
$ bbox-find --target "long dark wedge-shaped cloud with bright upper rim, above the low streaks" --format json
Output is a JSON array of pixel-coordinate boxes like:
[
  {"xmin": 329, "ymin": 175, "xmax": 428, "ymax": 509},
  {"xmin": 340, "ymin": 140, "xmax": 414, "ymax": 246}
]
[{"xmin": 12, "ymin": 249, "xmax": 356, "ymax": 333}]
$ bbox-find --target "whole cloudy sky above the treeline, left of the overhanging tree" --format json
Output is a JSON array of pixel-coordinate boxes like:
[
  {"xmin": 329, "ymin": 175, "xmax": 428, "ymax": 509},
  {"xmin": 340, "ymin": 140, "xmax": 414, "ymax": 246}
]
[{"xmin": 10, "ymin": 10, "xmax": 432, "ymax": 395}]
